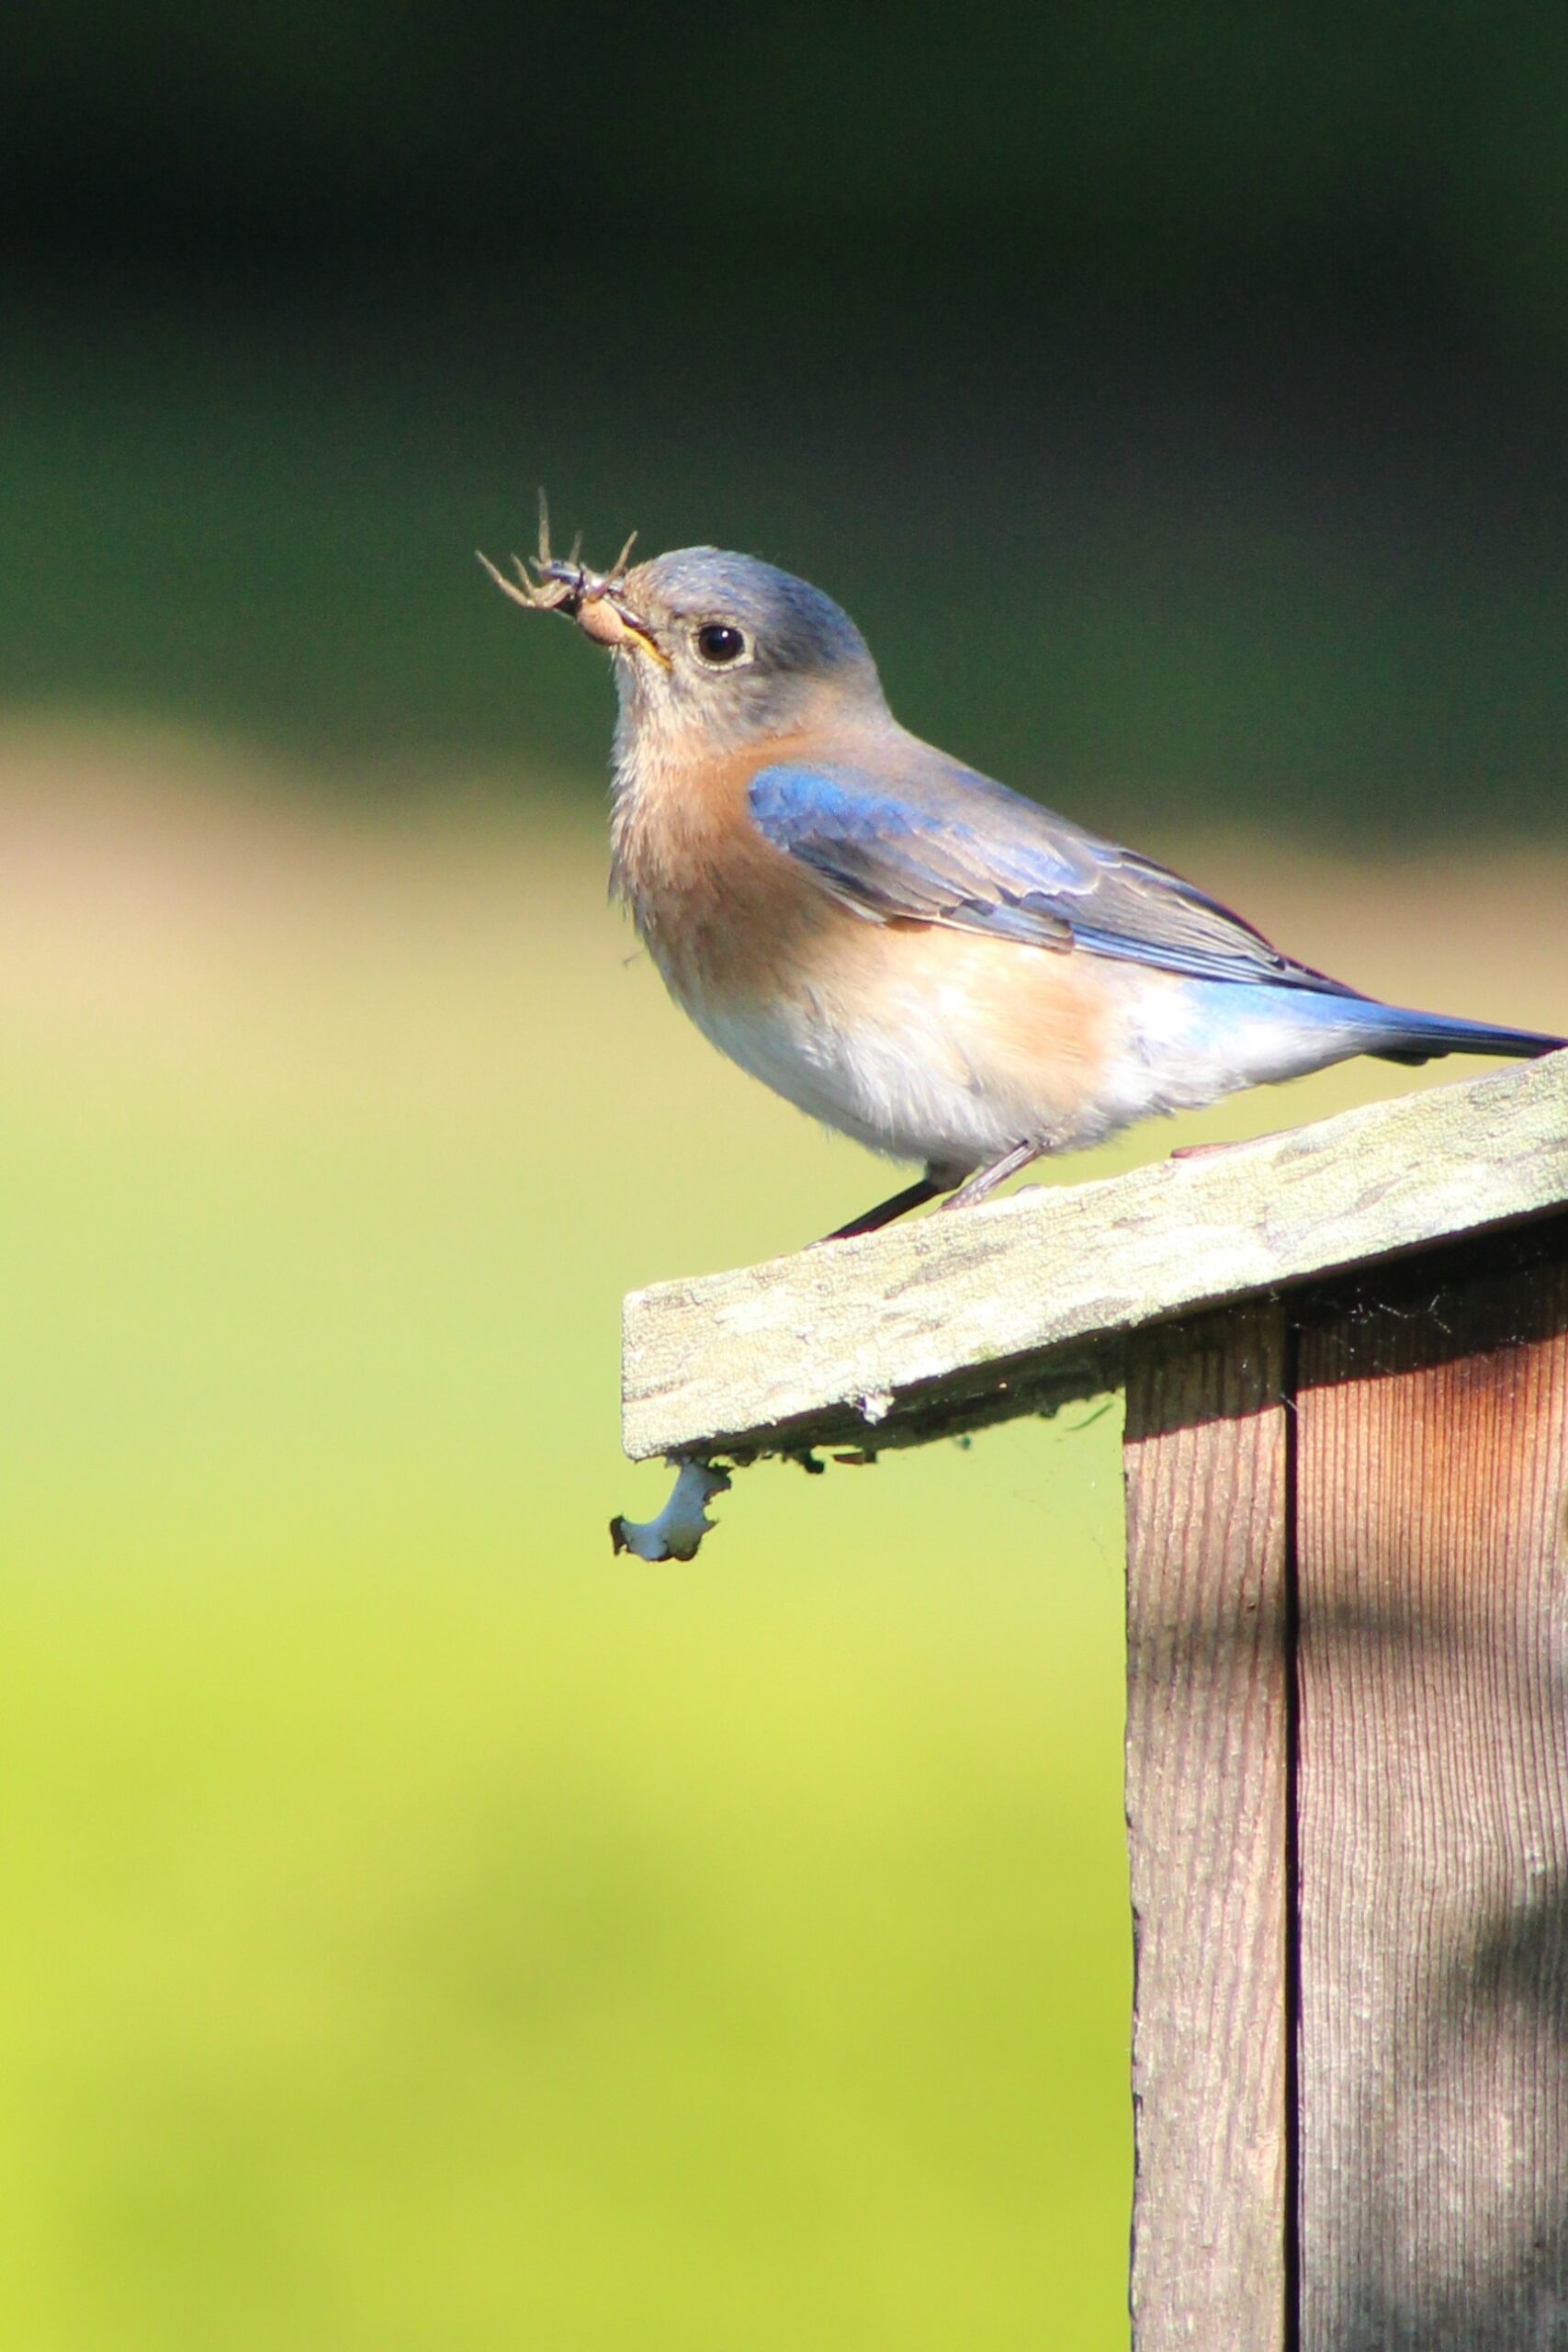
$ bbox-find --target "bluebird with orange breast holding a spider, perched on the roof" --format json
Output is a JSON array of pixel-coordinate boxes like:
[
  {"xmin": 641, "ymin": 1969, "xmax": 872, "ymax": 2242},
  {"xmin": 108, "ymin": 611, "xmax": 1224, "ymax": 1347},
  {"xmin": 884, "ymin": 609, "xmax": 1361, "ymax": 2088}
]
[{"xmin": 482, "ymin": 501, "xmax": 1565, "ymax": 1239}]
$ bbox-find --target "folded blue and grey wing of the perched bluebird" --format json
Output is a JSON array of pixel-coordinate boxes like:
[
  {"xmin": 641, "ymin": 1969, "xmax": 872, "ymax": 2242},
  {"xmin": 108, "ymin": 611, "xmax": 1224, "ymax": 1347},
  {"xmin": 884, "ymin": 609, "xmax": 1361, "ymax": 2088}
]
[{"xmin": 750, "ymin": 746, "xmax": 1357, "ymax": 995}]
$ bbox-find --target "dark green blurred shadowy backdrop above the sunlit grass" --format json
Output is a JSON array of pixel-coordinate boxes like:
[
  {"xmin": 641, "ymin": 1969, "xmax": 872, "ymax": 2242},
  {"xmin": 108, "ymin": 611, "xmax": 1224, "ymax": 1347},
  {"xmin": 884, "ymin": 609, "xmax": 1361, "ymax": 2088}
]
[{"xmin": 12, "ymin": 0, "xmax": 1568, "ymax": 837}]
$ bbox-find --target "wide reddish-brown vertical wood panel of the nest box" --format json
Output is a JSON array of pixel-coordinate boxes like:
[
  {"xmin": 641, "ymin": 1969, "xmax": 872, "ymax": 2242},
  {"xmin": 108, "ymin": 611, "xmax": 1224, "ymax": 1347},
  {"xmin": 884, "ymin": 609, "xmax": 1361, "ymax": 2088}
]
[{"xmin": 1295, "ymin": 1221, "xmax": 1568, "ymax": 2352}]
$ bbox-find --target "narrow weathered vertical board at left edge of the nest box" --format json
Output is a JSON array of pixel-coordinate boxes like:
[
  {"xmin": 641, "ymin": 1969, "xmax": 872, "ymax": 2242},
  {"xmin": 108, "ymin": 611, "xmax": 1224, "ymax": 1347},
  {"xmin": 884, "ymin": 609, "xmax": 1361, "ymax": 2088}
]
[{"xmin": 1126, "ymin": 1306, "xmax": 1291, "ymax": 2352}]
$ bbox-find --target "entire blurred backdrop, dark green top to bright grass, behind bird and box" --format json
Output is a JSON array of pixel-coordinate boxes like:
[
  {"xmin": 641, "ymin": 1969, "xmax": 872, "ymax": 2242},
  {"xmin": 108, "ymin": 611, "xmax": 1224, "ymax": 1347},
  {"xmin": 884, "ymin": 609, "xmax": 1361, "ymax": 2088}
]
[{"xmin": 0, "ymin": 0, "xmax": 1568, "ymax": 2352}]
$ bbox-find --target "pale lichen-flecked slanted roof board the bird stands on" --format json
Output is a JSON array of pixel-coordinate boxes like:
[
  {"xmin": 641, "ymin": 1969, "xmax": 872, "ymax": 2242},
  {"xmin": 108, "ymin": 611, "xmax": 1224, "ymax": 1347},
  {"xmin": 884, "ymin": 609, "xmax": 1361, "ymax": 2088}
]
[{"xmin": 623, "ymin": 1054, "xmax": 1568, "ymax": 1458}]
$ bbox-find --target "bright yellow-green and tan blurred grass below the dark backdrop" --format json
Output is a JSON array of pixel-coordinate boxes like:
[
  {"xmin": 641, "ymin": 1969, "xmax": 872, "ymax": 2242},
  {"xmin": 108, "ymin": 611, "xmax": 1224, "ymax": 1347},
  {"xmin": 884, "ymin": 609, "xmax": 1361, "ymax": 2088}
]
[{"xmin": 0, "ymin": 727, "xmax": 1563, "ymax": 2352}]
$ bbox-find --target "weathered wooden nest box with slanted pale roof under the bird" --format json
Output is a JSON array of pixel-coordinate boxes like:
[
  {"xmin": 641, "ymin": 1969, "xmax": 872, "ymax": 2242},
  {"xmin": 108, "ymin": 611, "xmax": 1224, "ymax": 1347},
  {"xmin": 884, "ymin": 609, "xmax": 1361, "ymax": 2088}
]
[{"xmin": 626, "ymin": 1054, "xmax": 1568, "ymax": 2352}]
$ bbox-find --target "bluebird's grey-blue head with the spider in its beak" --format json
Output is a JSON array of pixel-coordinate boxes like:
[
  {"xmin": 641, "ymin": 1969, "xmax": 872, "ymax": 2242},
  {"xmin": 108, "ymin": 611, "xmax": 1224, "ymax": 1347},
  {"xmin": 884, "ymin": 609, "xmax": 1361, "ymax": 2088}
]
[{"xmin": 479, "ymin": 501, "xmax": 884, "ymax": 748}]
